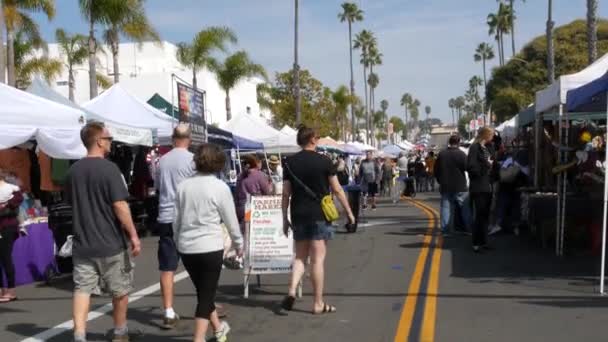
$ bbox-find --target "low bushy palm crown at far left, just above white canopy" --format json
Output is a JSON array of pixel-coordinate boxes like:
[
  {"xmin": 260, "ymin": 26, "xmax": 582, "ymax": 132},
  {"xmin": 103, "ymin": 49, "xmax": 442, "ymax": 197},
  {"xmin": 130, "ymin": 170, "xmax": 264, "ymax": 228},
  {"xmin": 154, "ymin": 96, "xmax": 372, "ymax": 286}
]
[{"xmin": 13, "ymin": 30, "xmax": 63, "ymax": 89}]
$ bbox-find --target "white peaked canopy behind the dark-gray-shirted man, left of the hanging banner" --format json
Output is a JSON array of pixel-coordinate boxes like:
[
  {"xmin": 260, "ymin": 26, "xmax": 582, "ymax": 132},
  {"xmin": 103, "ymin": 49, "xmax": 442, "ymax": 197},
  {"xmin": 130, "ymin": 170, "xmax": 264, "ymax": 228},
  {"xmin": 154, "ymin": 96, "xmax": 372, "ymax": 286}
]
[{"xmin": 82, "ymin": 83, "xmax": 174, "ymax": 140}]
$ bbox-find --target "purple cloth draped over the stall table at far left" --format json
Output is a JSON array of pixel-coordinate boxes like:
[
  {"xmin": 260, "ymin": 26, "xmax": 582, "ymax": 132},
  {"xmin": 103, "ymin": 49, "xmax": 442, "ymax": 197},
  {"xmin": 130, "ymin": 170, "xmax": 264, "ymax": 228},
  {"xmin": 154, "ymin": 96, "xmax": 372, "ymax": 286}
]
[{"xmin": 2, "ymin": 223, "xmax": 56, "ymax": 286}]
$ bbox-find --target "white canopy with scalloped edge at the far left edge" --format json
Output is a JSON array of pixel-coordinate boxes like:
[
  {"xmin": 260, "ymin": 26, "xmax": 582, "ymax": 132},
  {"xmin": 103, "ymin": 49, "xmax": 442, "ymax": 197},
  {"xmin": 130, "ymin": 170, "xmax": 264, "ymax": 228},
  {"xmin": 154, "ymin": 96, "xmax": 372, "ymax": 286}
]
[{"xmin": 0, "ymin": 84, "xmax": 86, "ymax": 159}]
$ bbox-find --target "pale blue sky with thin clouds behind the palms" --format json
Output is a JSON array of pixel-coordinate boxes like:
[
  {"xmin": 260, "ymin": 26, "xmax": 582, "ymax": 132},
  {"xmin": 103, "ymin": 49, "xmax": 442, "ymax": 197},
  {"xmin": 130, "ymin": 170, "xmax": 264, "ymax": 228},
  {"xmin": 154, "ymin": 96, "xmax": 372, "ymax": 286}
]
[{"xmin": 39, "ymin": 0, "xmax": 608, "ymax": 121}]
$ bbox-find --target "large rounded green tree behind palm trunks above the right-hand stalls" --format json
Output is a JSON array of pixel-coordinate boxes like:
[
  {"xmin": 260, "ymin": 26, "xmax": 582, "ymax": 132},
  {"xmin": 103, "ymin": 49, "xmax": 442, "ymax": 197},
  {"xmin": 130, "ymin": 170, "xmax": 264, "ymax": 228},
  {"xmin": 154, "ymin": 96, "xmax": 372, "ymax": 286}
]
[{"xmin": 487, "ymin": 20, "xmax": 608, "ymax": 121}]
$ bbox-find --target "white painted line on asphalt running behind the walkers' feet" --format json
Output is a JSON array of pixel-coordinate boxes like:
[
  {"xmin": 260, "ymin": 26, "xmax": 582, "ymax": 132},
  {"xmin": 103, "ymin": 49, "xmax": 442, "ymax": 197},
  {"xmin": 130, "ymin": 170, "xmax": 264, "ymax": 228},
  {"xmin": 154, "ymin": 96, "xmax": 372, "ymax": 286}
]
[{"xmin": 21, "ymin": 271, "xmax": 188, "ymax": 342}]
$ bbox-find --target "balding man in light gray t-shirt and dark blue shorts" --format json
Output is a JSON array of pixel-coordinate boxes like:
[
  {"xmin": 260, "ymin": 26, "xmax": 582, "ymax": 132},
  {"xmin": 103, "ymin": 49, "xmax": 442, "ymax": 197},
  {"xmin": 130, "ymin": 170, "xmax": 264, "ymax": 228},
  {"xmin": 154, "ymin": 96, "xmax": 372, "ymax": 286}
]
[{"xmin": 156, "ymin": 125, "xmax": 196, "ymax": 329}]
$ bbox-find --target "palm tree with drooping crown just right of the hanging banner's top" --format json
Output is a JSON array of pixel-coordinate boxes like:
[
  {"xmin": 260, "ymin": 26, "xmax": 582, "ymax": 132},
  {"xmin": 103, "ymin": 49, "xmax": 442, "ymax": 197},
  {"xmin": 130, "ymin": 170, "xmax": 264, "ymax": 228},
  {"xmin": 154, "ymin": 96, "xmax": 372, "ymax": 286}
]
[{"xmin": 209, "ymin": 51, "xmax": 268, "ymax": 121}]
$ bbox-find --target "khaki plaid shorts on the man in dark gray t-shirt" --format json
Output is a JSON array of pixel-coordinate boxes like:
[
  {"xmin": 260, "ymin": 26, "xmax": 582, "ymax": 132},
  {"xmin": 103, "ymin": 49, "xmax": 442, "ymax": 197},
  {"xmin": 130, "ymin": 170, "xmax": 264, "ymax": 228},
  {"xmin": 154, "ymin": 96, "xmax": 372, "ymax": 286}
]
[{"xmin": 73, "ymin": 251, "xmax": 133, "ymax": 297}]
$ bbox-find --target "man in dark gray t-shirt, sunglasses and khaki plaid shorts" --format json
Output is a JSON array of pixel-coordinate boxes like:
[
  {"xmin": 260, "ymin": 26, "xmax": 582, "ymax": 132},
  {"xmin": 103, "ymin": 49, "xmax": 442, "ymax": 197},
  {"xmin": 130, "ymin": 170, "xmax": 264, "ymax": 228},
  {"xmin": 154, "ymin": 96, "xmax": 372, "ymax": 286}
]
[{"xmin": 65, "ymin": 122, "xmax": 141, "ymax": 342}]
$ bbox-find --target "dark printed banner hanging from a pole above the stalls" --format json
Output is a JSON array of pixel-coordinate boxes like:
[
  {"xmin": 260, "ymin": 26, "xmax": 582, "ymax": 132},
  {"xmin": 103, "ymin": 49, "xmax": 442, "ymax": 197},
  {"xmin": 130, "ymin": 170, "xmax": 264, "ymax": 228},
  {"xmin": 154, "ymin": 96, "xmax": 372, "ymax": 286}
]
[{"xmin": 176, "ymin": 82, "xmax": 207, "ymax": 144}]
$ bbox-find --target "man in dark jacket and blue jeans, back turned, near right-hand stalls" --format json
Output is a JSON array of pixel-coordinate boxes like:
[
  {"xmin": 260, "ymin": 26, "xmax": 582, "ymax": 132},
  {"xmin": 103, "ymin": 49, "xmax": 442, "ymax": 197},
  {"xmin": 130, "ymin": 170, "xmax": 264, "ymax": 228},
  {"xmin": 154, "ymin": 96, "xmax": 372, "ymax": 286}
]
[{"xmin": 434, "ymin": 135, "xmax": 471, "ymax": 236}]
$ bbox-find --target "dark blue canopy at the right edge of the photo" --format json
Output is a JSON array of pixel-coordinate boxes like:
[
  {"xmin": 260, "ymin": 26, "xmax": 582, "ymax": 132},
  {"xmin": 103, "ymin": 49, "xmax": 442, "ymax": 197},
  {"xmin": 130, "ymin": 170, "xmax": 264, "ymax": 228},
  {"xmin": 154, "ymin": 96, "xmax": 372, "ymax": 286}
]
[{"xmin": 566, "ymin": 73, "xmax": 608, "ymax": 112}]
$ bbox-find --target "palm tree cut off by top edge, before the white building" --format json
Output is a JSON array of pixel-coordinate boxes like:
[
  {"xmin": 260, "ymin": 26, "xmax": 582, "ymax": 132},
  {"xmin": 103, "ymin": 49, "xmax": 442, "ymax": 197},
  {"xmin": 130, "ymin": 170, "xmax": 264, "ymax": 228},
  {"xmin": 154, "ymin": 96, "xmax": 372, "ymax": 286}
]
[{"xmin": 103, "ymin": 0, "xmax": 160, "ymax": 83}]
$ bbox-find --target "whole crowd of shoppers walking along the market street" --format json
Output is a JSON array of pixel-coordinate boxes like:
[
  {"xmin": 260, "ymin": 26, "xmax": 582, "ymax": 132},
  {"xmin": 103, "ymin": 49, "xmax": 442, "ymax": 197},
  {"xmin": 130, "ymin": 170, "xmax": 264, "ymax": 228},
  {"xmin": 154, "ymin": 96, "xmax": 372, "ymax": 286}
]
[{"xmin": 0, "ymin": 122, "xmax": 528, "ymax": 342}]
